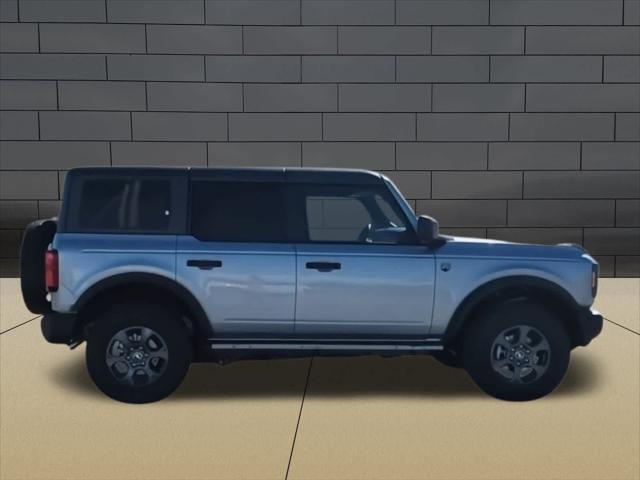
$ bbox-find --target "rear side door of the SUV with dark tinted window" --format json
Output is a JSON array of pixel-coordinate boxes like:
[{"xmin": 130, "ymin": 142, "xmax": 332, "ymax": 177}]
[{"xmin": 177, "ymin": 172, "xmax": 296, "ymax": 337}]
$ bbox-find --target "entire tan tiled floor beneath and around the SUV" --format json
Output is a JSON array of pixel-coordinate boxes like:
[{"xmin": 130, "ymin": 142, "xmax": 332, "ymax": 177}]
[{"xmin": 0, "ymin": 279, "xmax": 640, "ymax": 480}]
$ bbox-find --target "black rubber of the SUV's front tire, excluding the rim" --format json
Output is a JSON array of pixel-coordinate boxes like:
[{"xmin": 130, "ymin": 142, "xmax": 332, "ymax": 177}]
[{"xmin": 464, "ymin": 301, "xmax": 571, "ymax": 401}]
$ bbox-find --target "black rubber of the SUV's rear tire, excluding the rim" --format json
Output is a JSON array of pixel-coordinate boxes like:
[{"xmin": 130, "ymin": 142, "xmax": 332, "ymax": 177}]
[{"xmin": 86, "ymin": 304, "xmax": 192, "ymax": 403}]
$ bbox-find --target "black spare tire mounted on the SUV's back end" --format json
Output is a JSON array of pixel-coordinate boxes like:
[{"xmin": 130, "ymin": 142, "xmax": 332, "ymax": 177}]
[{"xmin": 20, "ymin": 218, "xmax": 58, "ymax": 313}]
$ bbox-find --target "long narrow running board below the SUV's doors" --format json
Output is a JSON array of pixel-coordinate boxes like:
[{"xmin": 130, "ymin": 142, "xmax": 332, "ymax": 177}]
[{"xmin": 209, "ymin": 340, "xmax": 443, "ymax": 352}]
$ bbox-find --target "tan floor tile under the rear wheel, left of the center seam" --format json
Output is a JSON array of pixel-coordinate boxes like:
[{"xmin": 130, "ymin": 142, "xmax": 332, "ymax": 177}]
[{"xmin": 0, "ymin": 322, "xmax": 308, "ymax": 480}]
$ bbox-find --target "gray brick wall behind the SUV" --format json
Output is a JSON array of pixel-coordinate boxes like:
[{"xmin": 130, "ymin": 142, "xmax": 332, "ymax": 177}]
[{"xmin": 0, "ymin": 0, "xmax": 640, "ymax": 276}]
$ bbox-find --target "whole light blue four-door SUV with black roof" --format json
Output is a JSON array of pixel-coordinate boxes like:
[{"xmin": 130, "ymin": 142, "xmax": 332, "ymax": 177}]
[{"xmin": 21, "ymin": 168, "xmax": 602, "ymax": 403}]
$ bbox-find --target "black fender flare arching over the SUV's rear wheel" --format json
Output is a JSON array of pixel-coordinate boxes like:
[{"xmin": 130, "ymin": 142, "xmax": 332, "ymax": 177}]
[{"xmin": 72, "ymin": 272, "xmax": 213, "ymax": 337}]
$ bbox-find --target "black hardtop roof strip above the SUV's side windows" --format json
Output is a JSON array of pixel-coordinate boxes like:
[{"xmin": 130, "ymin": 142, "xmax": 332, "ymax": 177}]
[{"xmin": 67, "ymin": 167, "xmax": 382, "ymax": 185}]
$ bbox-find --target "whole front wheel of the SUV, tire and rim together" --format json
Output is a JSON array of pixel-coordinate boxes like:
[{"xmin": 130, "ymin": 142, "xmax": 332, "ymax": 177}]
[{"xmin": 463, "ymin": 300, "xmax": 571, "ymax": 401}]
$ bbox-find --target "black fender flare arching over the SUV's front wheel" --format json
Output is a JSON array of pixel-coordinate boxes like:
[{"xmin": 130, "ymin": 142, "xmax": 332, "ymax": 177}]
[{"xmin": 442, "ymin": 275, "xmax": 580, "ymax": 344}]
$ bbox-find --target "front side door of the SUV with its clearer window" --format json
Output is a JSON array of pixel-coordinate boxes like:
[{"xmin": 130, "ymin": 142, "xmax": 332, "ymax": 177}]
[{"xmin": 291, "ymin": 185, "xmax": 435, "ymax": 339}]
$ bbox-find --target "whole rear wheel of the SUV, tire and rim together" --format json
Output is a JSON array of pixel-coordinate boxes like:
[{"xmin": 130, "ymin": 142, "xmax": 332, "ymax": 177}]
[{"xmin": 86, "ymin": 303, "xmax": 192, "ymax": 403}]
